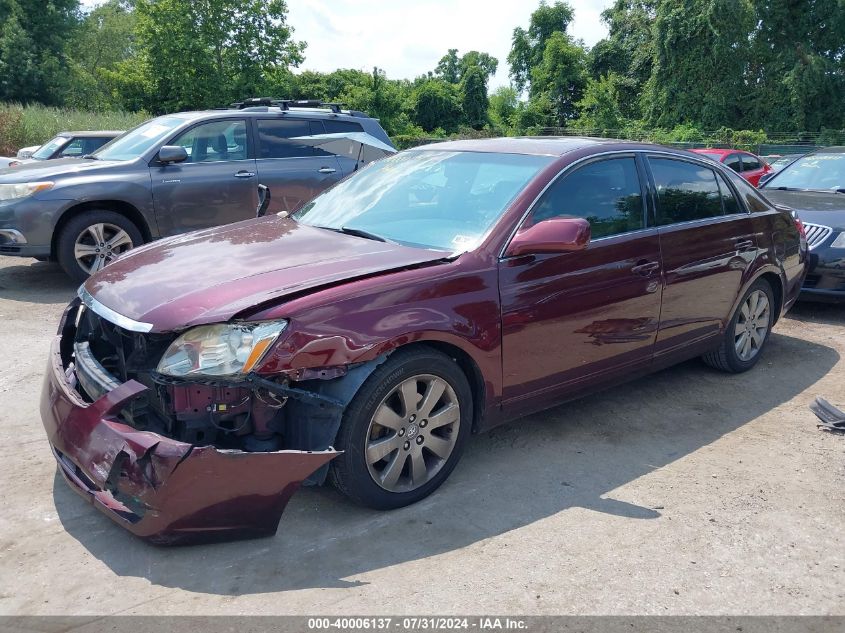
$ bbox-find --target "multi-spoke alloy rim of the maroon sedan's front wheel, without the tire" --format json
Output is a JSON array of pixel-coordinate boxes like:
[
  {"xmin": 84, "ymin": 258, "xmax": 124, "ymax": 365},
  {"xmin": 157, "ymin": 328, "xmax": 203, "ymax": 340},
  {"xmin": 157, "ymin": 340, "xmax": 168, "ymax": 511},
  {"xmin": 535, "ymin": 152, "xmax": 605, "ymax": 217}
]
[{"xmin": 366, "ymin": 374, "xmax": 461, "ymax": 492}]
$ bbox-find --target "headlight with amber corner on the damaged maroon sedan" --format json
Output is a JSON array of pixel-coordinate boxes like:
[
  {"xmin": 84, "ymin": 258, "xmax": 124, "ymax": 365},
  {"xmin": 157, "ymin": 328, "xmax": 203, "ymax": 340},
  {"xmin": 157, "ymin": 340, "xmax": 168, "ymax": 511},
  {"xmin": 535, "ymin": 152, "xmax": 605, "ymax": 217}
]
[{"xmin": 157, "ymin": 321, "xmax": 288, "ymax": 377}]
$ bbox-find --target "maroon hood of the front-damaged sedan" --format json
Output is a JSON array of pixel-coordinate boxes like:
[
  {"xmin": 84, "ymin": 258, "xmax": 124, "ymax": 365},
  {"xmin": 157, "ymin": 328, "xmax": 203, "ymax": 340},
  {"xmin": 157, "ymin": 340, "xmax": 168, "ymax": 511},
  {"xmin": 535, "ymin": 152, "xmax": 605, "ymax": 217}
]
[{"xmin": 84, "ymin": 215, "xmax": 449, "ymax": 332}]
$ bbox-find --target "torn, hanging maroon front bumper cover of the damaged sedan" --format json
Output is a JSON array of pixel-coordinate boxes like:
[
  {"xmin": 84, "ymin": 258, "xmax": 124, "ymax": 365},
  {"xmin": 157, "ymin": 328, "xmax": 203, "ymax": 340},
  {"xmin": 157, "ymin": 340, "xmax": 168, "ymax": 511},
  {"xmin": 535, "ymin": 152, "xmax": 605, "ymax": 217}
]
[{"xmin": 41, "ymin": 336, "xmax": 339, "ymax": 544}]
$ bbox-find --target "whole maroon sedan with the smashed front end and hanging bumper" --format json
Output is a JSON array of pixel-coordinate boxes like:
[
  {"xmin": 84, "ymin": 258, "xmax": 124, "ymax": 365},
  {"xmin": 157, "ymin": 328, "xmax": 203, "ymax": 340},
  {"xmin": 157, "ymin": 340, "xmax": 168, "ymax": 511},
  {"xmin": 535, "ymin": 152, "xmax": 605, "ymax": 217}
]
[{"xmin": 41, "ymin": 138, "xmax": 807, "ymax": 543}]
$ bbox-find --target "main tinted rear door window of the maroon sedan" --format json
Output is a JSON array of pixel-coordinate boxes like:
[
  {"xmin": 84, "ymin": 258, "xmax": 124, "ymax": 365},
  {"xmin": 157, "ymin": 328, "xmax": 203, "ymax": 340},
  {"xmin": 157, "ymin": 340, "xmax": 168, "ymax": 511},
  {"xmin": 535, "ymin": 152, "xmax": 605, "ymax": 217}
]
[{"xmin": 648, "ymin": 157, "xmax": 723, "ymax": 226}]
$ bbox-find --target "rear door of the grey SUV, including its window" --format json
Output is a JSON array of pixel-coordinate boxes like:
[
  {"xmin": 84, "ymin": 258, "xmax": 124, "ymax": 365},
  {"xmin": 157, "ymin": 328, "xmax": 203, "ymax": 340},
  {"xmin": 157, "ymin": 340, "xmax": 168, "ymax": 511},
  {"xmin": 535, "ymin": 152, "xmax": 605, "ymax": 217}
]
[{"xmin": 255, "ymin": 118, "xmax": 343, "ymax": 213}]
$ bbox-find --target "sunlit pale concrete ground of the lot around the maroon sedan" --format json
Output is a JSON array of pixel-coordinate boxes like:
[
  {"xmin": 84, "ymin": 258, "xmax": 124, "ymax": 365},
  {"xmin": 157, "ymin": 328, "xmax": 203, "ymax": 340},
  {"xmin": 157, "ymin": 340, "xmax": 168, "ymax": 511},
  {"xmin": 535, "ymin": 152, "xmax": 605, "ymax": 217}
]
[{"xmin": 0, "ymin": 257, "xmax": 845, "ymax": 615}]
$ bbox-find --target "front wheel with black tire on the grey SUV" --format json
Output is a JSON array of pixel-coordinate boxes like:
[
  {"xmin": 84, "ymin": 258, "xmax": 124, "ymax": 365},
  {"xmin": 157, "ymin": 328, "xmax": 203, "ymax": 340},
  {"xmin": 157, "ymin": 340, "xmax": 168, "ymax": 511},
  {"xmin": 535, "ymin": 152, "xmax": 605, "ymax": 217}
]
[{"xmin": 56, "ymin": 209, "xmax": 144, "ymax": 283}]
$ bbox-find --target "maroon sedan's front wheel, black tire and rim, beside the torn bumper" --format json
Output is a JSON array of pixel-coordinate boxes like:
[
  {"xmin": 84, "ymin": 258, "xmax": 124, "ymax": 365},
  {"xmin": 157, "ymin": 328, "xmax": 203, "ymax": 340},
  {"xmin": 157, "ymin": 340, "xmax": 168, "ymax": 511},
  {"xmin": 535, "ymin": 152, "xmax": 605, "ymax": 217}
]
[{"xmin": 330, "ymin": 347, "xmax": 473, "ymax": 510}]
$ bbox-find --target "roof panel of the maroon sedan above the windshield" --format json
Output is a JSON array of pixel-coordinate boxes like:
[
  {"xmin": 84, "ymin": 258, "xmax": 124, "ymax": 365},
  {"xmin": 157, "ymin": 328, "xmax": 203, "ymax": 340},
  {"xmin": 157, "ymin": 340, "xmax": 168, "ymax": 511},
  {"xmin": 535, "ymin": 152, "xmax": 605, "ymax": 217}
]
[{"xmin": 414, "ymin": 136, "xmax": 657, "ymax": 156}]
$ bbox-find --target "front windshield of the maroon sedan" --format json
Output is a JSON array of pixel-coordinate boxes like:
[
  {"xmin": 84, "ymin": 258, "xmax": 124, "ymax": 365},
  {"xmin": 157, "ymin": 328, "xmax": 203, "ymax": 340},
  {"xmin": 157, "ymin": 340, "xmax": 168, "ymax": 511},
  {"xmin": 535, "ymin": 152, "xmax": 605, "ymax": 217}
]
[{"xmin": 293, "ymin": 150, "xmax": 553, "ymax": 253}]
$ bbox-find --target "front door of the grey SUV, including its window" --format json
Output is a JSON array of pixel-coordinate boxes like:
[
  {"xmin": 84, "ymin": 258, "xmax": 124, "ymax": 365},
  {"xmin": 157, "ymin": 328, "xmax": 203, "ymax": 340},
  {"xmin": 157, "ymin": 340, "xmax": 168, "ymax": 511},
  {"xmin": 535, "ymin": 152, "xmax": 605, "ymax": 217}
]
[{"xmin": 150, "ymin": 119, "xmax": 258, "ymax": 236}]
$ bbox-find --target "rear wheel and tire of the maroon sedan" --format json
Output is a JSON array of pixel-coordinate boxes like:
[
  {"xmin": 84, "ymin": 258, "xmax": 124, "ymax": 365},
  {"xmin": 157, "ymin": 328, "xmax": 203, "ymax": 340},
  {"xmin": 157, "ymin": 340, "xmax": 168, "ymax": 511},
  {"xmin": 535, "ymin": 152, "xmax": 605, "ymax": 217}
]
[{"xmin": 702, "ymin": 279, "xmax": 775, "ymax": 374}]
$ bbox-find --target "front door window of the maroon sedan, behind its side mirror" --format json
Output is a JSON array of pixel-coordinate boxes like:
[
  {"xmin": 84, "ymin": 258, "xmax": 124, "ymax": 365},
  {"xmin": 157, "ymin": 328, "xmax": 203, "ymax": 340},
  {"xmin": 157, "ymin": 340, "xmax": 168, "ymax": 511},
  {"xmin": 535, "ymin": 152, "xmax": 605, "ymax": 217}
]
[{"xmin": 532, "ymin": 157, "xmax": 644, "ymax": 238}]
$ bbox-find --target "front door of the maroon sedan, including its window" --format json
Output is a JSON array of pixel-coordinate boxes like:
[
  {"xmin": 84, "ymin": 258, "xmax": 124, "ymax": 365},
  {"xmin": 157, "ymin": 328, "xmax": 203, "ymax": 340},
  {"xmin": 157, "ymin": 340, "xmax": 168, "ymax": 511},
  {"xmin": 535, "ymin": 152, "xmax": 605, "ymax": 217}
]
[{"xmin": 499, "ymin": 155, "xmax": 661, "ymax": 414}]
